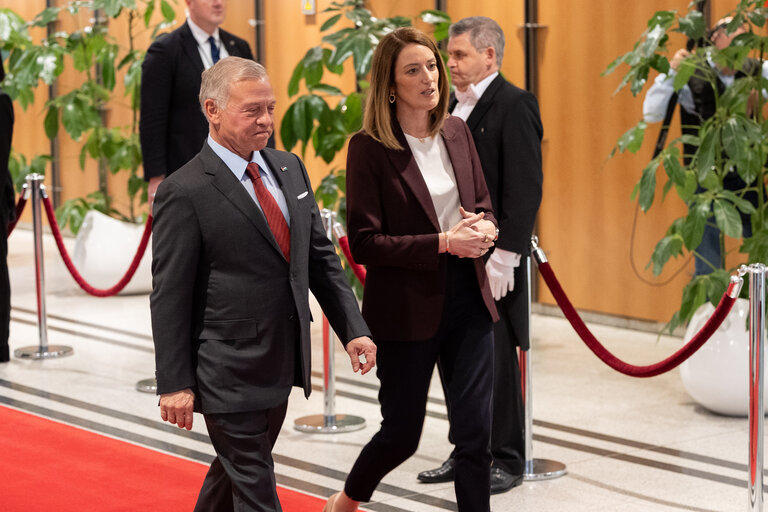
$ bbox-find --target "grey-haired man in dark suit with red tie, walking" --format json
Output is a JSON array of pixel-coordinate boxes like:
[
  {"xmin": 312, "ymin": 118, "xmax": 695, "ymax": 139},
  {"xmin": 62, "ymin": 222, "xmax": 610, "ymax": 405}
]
[{"xmin": 150, "ymin": 57, "xmax": 376, "ymax": 512}]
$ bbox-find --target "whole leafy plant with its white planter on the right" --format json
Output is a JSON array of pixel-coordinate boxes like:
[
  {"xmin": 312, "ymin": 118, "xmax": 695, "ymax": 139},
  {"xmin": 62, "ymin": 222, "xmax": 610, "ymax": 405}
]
[{"xmin": 605, "ymin": 0, "xmax": 768, "ymax": 415}]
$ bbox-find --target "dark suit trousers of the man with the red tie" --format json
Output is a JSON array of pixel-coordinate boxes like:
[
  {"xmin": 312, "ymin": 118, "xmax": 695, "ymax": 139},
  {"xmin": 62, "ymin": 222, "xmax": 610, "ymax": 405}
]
[{"xmin": 195, "ymin": 401, "xmax": 288, "ymax": 512}]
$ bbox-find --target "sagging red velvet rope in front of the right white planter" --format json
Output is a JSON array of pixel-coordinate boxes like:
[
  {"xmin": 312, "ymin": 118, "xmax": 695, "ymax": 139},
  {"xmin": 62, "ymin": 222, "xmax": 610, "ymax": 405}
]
[{"xmin": 539, "ymin": 261, "xmax": 736, "ymax": 377}]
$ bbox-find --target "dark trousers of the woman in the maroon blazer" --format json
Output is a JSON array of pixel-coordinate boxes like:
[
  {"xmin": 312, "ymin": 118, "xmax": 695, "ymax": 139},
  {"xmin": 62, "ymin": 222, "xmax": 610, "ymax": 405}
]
[{"xmin": 344, "ymin": 256, "xmax": 493, "ymax": 512}]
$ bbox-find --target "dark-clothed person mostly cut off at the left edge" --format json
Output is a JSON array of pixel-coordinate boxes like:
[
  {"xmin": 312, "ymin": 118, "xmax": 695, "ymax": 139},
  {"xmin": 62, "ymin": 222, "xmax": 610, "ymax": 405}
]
[{"xmin": 0, "ymin": 59, "xmax": 16, "ymax": 363}]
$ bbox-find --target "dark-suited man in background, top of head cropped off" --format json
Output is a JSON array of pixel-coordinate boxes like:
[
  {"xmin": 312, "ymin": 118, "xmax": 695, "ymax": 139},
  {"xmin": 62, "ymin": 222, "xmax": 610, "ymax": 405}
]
[{"xmin": 139, "ymin": 0, "xmax": 255, "ymax": 207}]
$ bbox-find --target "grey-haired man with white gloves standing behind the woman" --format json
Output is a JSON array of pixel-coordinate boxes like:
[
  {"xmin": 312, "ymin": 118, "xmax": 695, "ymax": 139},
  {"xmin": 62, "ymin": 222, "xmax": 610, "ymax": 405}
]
[{"xmin": 419, "ymin": 16, "xmax": 542, "ymax": 493}]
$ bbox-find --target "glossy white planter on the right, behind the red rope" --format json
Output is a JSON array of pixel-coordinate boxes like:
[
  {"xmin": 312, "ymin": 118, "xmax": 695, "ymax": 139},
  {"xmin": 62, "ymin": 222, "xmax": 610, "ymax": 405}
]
[{"xmin": 680, "ymin": 299, "xmax": 768, "ymax": 416}]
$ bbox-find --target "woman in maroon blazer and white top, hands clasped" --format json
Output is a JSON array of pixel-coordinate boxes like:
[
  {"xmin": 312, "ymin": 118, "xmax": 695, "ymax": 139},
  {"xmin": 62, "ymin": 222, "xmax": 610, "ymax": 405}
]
[{"xmin": 324, "ymin": 28, "xmax": 497, "ymax": 512}]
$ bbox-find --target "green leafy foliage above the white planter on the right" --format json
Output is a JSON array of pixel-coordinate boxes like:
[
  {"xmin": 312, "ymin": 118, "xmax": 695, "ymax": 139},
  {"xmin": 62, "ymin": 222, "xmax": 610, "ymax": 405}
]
[{"xmin": 604, "ymin": 0, "xmax": 768, "ymax": 332}]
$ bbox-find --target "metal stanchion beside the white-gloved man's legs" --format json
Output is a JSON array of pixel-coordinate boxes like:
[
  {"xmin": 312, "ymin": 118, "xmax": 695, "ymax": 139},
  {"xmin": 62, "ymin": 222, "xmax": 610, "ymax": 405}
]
[{"xmin": 520, "ymin": 236, "xmax": 566, "ymax": 480}]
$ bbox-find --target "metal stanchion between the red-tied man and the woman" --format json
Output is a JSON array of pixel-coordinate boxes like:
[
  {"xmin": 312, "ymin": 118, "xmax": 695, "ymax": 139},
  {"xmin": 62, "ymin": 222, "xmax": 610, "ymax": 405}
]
[{"xmin": 293, "ymin": 208, "xmax": 365, "ymax": 434}]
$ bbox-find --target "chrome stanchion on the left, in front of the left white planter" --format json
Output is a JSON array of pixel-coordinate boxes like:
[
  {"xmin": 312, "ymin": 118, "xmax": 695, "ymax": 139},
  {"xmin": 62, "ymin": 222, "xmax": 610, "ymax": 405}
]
[{"xmin": 13, "ymin": 173, "xmax": 72, "ymax": 359}]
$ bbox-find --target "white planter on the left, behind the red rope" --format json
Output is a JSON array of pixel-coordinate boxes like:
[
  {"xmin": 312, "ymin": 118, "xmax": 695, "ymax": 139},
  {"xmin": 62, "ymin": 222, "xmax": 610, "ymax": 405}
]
[{"xmin": 72, "ymin": 210, "xmax": 152, "ymax": 295}]
